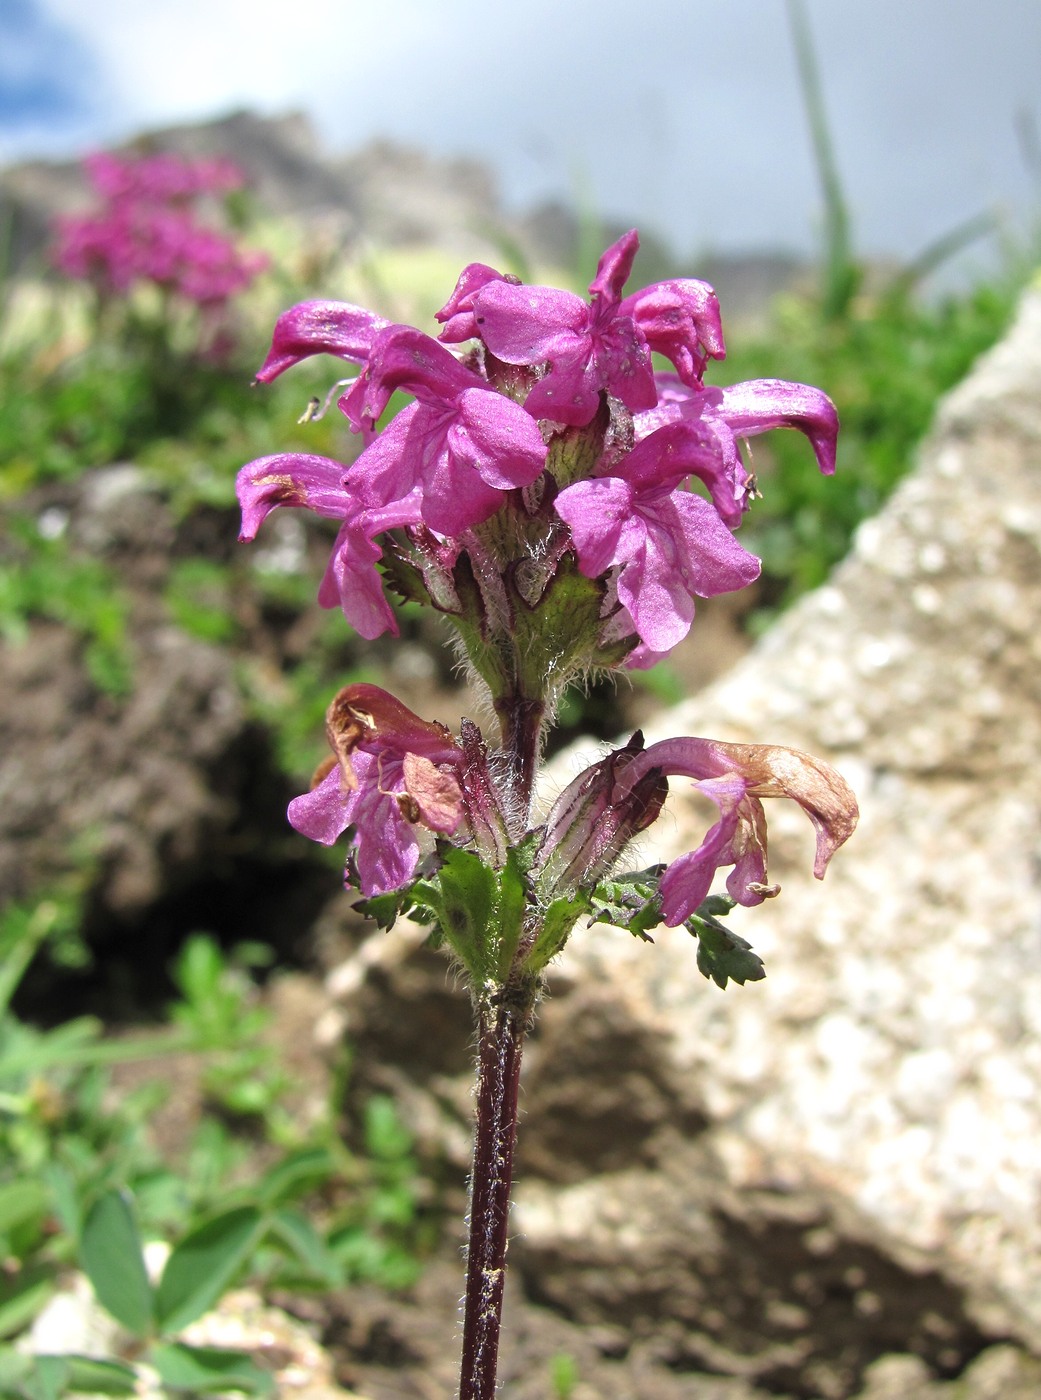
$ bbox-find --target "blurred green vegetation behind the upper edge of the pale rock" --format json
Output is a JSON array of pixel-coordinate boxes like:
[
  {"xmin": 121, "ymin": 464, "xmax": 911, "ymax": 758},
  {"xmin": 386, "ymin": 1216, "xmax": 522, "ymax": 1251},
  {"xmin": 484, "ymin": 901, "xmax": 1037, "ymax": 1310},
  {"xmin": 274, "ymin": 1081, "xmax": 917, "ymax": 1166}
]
[{"xmin": 718, "ymin": 273, "xmax": 1023, "ymax": 609}]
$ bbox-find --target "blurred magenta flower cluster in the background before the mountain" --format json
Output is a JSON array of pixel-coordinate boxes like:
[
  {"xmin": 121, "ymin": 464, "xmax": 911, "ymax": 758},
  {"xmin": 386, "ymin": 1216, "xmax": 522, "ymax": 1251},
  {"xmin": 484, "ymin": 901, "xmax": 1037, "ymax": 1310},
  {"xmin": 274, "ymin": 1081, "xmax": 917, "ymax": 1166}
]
[{"xmin": 53, "ymin": 153, "xmax": 267, "ymax": 311}]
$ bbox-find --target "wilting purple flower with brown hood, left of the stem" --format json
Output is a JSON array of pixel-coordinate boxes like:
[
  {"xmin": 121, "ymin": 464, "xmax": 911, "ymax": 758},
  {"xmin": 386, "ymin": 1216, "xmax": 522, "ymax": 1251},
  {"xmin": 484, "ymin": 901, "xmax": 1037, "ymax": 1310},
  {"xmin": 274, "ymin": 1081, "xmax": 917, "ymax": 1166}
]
[{"xmin": 288, "ymin": 685, "xmax": 463, "ymax": 897}]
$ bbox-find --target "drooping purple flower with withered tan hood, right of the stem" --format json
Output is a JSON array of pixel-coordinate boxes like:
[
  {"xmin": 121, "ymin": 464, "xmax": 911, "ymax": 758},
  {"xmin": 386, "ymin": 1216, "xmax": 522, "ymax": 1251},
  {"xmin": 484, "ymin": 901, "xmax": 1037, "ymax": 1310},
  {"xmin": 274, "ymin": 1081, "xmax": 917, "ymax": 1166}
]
[{"xmin": 611, "ymin": 738, "xmax": 859, "ymax": 925}]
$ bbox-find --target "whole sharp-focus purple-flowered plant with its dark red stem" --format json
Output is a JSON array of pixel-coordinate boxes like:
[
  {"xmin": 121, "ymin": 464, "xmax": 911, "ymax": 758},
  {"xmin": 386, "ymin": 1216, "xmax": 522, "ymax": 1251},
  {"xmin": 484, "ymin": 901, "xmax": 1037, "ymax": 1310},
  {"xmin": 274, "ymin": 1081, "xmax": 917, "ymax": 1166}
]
[{"xmin": 238, "ymin": 232, "xmax": 858, "ymax": 1400}]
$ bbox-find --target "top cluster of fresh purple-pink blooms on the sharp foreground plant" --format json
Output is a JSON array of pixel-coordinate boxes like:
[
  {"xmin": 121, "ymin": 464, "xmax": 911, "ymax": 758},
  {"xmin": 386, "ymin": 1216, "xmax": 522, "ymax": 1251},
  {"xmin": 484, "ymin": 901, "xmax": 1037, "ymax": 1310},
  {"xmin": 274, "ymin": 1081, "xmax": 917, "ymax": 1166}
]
[{"xmin": 238, "ymin": 232, "xmax": 838, "ymax": 666}]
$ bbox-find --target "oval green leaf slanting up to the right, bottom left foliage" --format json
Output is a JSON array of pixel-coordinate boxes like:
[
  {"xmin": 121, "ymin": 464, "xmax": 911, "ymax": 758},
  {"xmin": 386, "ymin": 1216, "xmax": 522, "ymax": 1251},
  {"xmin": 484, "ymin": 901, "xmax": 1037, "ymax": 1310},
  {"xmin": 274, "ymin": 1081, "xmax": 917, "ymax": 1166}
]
[{"xmin": 155, "ymin": 1205, "xmax": 264, "ymax": 1333}]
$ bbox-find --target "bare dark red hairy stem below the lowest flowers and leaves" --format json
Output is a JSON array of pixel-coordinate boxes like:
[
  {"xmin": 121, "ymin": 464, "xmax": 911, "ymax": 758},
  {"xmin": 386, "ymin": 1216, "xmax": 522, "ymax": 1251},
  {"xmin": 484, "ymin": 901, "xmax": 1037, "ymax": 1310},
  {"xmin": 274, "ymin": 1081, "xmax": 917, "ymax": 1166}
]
[{"xmin": 459, "ymin": 998, "xmax": 530, "ymax": 1400}]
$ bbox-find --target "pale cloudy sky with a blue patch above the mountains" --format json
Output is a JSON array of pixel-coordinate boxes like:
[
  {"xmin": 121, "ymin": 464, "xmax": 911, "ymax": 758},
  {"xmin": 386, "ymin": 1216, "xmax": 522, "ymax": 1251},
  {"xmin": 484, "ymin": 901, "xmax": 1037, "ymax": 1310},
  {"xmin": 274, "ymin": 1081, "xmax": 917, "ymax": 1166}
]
[{"xmin": 0, "ymin": 0, "xmax": 1041, "ymax": 258}]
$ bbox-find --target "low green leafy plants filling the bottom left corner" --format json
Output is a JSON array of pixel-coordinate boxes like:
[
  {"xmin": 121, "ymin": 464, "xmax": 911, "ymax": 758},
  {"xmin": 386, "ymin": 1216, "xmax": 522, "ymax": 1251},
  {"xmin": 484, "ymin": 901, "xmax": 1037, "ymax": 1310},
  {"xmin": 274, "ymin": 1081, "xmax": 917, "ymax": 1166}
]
[{"xmin": 0, "ymin": 924, "xmax": 423, "ymax": 1400}]
